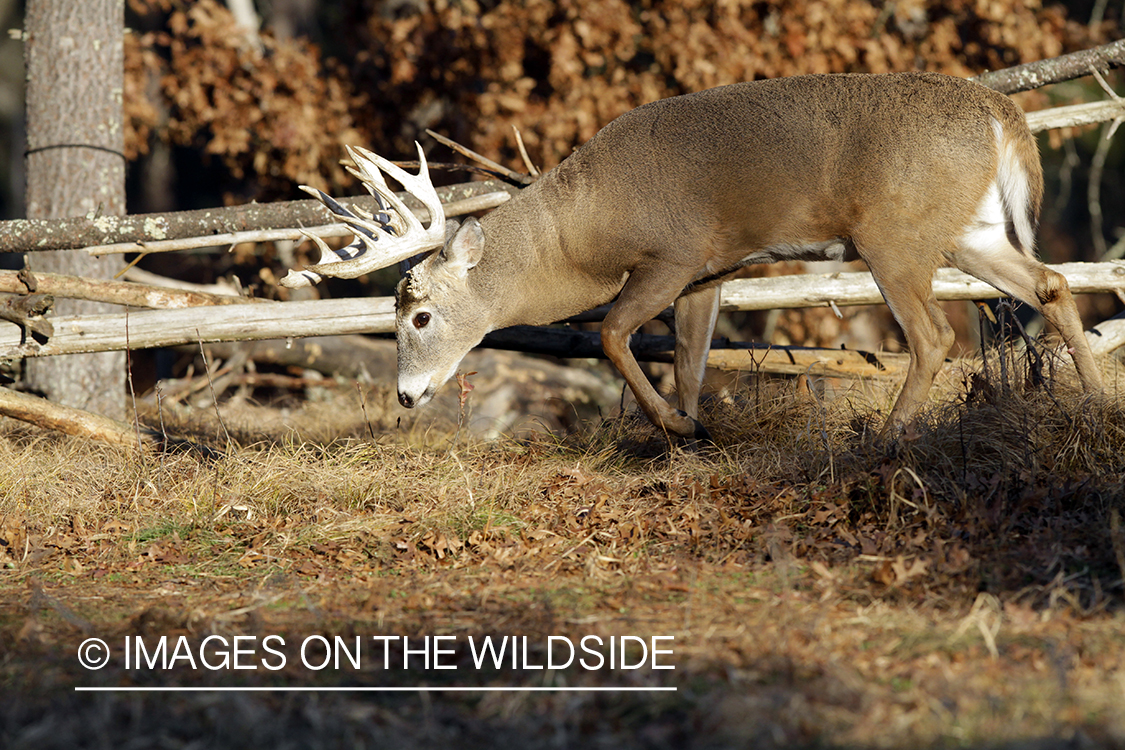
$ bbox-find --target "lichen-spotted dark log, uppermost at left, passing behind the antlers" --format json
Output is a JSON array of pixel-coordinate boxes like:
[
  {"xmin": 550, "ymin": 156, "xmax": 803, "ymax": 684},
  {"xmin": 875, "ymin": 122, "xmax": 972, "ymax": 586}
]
[{"xmin": 0, "ymin": 180, "xmax": 518, "ymax": 253}]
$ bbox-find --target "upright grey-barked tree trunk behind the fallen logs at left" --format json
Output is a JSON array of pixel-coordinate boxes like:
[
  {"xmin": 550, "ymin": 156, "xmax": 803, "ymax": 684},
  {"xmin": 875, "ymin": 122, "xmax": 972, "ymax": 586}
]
[{"xmin": 25, "ymin": 0, "xmax": 125, "ymax": 419}]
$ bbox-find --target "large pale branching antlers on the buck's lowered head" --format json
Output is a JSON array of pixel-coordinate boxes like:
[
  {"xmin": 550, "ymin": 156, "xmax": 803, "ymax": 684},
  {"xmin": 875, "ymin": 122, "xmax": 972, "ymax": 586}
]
[{"xmin": 280, "ymin": 143, "xmax": 446, "ymax": 289}]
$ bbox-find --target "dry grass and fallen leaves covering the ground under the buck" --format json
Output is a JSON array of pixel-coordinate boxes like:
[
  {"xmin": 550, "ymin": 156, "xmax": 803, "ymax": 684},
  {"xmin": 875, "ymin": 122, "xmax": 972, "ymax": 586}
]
[{"xmin": 0, "ymin": 348, "xmax": 1125, "ymax": 748}]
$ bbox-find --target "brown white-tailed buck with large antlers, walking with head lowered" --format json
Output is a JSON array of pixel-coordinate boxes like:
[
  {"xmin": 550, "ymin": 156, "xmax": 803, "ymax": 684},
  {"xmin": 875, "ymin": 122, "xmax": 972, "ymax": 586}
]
[{"xmin": 281, "ymin": 73, "xmax": 1103, "ymax": 441}]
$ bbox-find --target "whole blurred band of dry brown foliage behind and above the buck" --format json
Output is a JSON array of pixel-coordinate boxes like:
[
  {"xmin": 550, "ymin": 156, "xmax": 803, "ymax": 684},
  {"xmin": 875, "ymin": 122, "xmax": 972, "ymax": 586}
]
[{"xmin": 126, "ymin": 0, "xmax": 1113, "ymax": 199}]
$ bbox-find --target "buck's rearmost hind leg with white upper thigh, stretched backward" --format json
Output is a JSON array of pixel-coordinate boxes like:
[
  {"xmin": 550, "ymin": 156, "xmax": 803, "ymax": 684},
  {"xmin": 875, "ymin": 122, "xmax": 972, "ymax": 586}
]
[{"xmin": 953, "ymin": 220, "xmax": 1103, "ymax": 391}]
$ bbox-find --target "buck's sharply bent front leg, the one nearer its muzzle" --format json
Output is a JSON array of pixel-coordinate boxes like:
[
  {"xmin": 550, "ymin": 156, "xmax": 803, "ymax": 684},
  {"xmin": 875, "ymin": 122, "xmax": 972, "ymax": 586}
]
[{"xmin": 602, "ymin": 269, "xmax": 711, "ymax": 441}]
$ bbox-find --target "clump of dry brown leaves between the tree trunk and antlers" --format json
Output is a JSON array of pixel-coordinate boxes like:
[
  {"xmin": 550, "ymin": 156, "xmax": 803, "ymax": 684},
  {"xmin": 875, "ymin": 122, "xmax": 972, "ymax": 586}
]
[{"xmin": 126, "ymin": 0, "xmax": 363, "ymax": 192}]
